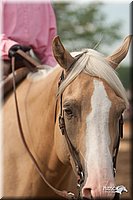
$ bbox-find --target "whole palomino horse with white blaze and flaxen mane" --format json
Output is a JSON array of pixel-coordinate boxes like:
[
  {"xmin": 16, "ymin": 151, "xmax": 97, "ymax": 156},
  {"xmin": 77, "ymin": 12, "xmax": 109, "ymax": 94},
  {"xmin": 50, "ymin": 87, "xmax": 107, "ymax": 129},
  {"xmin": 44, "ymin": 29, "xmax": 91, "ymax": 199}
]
[{"xmin": 3, "ymin": 36, "xmax": 131, "ymax": 199}]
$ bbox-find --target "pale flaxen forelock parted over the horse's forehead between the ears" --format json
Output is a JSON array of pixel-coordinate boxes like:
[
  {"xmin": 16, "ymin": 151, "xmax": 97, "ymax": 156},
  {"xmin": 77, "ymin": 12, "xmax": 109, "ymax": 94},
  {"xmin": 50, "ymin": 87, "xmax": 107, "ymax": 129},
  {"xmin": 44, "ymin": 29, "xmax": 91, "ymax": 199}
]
[{"xmin": 58, "ymin": 49, "xmax": 128, "ymax": 106}]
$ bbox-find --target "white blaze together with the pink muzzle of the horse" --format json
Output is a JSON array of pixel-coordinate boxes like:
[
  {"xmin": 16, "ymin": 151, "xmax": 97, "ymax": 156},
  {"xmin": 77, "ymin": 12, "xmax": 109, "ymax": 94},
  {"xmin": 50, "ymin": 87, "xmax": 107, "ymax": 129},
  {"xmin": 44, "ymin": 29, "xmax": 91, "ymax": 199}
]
[{"xmin": 82, "ymin": 79, "xmax": 115, "ymax": 199}]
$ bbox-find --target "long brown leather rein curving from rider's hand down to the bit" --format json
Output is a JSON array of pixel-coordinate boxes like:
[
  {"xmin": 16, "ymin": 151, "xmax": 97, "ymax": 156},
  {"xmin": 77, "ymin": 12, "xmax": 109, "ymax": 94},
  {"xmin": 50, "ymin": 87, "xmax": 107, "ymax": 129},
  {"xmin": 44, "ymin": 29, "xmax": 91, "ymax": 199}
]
[{"xmin": 11, "ymin": 57, "xmax": 76, "ymax": 200}]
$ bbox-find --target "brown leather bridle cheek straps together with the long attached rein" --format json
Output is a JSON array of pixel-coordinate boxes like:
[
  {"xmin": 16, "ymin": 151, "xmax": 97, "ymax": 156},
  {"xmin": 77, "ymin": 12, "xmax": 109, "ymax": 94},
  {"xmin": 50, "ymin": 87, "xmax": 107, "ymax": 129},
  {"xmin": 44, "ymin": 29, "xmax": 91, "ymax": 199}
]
[{"xmin": 11, "ymin": 50, "xmax": 123, "ymax": 200}]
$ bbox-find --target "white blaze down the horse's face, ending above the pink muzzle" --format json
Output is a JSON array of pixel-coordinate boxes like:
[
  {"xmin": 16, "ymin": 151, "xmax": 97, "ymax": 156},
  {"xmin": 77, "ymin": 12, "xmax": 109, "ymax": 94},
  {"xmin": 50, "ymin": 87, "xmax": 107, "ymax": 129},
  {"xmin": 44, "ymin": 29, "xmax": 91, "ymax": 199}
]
[{"xmin": 85, "ymin": 79, "xmax": 112, "ymax": 179}]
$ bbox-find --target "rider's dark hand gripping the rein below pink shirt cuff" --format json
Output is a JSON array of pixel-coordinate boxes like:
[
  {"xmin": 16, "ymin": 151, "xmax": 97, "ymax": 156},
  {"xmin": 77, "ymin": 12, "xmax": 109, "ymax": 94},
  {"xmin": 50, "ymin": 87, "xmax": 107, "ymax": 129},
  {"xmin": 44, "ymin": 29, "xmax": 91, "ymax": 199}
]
[{"xmin": 8, "ymin": 44, "xmax": 31, "ymax": 58}]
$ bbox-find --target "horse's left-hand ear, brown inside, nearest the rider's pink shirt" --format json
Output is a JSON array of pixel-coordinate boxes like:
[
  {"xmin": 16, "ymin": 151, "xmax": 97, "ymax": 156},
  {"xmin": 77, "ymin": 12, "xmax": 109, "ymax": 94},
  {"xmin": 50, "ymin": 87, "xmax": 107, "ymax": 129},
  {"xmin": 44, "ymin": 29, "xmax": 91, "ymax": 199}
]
[{"xmin": 52, "ymin": 36, "xmax": 75, "ymax": 70}]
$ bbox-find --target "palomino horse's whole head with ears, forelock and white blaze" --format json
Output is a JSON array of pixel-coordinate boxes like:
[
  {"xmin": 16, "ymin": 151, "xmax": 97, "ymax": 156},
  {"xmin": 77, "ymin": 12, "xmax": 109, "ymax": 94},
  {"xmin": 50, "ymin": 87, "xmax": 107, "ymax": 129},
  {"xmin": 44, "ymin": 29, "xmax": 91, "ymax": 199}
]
[{"xmin": 53, "ymin": 36, "xmax": 131, "ymax": 199}]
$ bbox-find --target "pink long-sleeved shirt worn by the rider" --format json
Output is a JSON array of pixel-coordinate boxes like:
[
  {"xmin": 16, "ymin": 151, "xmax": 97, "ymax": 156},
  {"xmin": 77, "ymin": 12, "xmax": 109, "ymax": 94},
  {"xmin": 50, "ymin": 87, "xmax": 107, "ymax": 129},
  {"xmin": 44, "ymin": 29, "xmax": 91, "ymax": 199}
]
[{"xmin": 0, "ymin": 0, "xmax": 56, "ymax": 66}]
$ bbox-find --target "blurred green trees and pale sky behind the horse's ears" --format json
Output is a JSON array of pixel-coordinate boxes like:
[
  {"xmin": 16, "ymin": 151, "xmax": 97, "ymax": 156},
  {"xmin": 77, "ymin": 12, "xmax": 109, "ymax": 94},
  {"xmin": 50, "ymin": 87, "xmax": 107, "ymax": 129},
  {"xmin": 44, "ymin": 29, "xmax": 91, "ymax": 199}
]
[{"xmin": 53, "ymin": 0, "xmax": 131, "ymax": 92}]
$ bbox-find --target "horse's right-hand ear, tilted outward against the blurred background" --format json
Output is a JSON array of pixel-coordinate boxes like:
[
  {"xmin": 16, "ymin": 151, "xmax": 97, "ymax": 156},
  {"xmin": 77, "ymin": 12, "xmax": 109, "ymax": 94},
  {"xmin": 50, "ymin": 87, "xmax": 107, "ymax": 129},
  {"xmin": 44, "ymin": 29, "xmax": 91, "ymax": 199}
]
[{"xmin": 106, "ymin": 35, "xmax": 133, "ymax": 69}]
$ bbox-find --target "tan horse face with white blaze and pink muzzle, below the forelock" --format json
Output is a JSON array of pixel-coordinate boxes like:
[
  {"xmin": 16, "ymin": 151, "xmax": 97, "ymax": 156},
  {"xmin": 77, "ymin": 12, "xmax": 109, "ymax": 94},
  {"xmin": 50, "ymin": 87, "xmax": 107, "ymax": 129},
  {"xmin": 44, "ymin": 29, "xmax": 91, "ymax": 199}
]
[{"xmin": 56, "ymin": 73, "xmax": 125, "ymax": 198}]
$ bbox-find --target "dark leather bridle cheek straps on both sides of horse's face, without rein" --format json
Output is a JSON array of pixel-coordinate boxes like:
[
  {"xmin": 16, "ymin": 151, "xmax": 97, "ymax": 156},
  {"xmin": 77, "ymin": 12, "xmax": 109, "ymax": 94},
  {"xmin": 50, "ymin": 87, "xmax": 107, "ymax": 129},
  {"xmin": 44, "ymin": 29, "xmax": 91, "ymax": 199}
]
[{"xmin": 58, "ymin": 71, "xmax": 123, "ymax": 200}]
